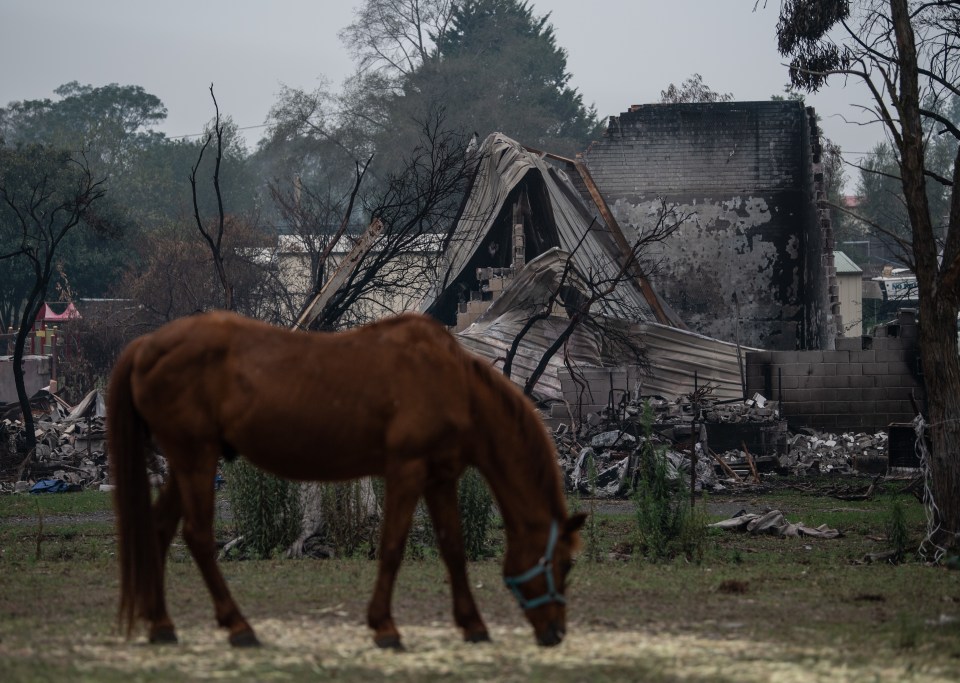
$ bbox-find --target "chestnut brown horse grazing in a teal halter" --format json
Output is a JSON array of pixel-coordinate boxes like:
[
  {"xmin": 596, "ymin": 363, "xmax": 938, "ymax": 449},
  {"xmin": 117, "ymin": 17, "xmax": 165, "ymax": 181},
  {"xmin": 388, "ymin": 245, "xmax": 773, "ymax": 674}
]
[{"xmin": 107, "ymin": 312, "xmax": 584, "ymax": 648}]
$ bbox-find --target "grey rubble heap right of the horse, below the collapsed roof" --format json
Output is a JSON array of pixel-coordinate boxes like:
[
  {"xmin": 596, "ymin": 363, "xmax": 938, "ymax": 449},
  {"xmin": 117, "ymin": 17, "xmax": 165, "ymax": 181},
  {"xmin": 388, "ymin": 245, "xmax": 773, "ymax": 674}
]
[{"xmin": 554, "ymin": 394, "xmax": 912, "ymax": 498}]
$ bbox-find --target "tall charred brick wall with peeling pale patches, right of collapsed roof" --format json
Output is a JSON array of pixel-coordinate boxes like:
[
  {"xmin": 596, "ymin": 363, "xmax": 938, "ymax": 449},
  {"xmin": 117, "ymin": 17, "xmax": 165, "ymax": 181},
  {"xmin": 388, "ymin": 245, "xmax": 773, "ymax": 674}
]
[{"xmin": 583, "ymin": 101, "xmax": 834, "ymax": 350}]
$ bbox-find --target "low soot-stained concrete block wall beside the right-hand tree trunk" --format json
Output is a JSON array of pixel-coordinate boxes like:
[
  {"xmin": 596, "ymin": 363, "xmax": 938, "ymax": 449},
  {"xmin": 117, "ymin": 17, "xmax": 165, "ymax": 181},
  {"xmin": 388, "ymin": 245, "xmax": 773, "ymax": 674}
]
[{"xmin": 746, "ymin": 315, "xmax": 925, "ymax": 432}]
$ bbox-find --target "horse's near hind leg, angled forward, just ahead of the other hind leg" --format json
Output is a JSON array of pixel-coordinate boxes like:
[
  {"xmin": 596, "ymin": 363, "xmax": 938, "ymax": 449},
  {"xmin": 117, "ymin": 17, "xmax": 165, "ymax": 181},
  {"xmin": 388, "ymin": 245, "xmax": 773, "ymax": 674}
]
[{"xmin": 171, "ymin": 451, "xmax": 260, "ymax": 647}]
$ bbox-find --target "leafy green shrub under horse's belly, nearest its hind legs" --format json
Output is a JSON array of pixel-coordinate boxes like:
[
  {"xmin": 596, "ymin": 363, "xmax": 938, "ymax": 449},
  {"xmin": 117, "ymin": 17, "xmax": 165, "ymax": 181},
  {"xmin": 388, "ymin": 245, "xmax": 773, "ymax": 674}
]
[{"xmin": 225, "ymin": 458, "xmax": 301, "ymax": 559}]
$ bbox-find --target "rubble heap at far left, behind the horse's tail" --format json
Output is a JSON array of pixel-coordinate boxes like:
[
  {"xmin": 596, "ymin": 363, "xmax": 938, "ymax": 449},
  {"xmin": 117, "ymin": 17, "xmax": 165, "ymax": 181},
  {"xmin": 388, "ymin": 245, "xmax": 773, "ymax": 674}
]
[{"xmin": 0, "ymin": 391, "xmax": 108, "ymax": 493}]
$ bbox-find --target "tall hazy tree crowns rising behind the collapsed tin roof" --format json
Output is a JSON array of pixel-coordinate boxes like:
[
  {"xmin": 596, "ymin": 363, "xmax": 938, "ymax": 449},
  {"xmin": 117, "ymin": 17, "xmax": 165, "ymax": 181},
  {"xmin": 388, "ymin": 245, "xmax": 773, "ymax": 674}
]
[{"xmin": 341, "ymin": 0, "xmax": 598, "ymax": 166}]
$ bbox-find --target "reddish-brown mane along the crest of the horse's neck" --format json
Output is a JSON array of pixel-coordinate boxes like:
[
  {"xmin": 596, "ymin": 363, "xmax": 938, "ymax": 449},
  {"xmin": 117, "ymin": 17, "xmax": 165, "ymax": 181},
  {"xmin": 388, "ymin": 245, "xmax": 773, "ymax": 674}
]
[{"xmin": 465, "ymin": 352, "xmax": 566, "ymax": 515}]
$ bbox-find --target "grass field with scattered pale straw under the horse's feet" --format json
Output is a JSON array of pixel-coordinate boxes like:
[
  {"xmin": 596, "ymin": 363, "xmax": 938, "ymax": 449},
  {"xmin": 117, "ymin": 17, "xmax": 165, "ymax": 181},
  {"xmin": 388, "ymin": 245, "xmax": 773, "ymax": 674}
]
[{"xmin": 0, "ymin": 479, "xmax": 960, "ymax": 683}]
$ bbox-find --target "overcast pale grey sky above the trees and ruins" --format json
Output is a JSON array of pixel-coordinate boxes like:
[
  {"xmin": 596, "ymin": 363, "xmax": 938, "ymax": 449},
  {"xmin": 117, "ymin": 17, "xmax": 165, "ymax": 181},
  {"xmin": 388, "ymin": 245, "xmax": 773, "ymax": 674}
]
[{"xmin": 0, "ymin": 0, "xmax": 882, "ymax": 189}]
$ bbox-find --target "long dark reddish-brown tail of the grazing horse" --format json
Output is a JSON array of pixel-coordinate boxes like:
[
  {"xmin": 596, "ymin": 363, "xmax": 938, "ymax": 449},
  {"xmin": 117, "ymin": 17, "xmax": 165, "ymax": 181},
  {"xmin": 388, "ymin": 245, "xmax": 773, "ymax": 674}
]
[{"xmin": 107, "ymin": 341, "xmax": 163, "ymax": 637}]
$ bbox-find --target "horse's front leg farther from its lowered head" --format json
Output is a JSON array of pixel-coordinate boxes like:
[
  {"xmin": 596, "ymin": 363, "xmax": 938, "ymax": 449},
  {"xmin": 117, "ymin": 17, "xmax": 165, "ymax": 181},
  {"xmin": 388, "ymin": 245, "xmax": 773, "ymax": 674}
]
[{"xmin": 367, "ymin": 463, "xmax": 423, "ymax": 650}]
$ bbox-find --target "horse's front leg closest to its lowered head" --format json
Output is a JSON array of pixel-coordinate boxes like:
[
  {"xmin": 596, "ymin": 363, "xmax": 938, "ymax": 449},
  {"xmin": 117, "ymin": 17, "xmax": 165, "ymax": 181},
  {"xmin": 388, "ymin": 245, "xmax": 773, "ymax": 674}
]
[{"xmin": 424, "ymin": 480, "xmax": 490, "ymax": 643}]
